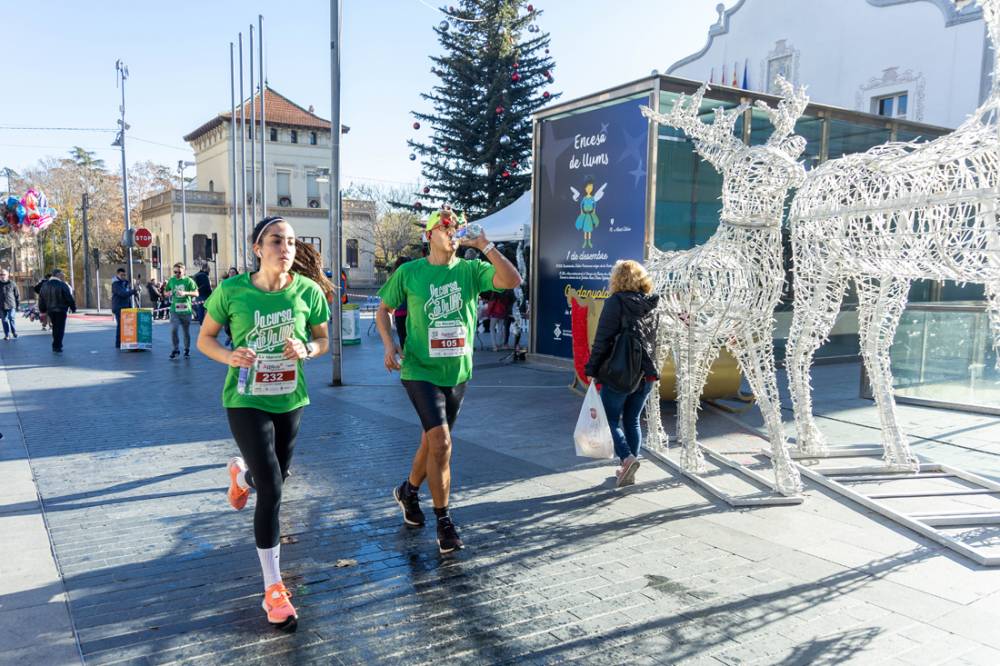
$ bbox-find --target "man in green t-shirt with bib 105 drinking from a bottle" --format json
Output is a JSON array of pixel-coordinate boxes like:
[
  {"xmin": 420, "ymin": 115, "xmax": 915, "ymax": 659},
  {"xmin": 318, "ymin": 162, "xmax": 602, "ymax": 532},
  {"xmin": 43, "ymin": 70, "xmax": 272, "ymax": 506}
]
[{"xmin": 375, "ymin": 205, "xmax": 521, "ymax": 553}]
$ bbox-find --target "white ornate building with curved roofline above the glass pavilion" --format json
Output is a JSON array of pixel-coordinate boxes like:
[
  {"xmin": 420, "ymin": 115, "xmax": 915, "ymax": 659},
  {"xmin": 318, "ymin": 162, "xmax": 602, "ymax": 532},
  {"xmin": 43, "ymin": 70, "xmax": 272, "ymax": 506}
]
[{"xmin": 666, "ymin": 0, "xmax": 993, "ymax": 128}]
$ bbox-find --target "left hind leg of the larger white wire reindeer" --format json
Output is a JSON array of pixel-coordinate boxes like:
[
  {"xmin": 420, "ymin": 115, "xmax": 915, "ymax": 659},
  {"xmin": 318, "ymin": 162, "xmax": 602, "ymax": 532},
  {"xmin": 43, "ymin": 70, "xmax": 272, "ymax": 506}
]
[{"xmin": 785, "ymin": 266, "xmax": 847, "ymax": 456}]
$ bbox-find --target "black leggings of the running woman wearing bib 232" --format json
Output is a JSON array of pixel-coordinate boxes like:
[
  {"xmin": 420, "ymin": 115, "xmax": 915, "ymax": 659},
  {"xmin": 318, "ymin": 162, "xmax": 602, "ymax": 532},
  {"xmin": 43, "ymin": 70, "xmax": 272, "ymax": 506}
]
[{"xmin": 226, "ymin": 407, "xmax": 302, "ymax": 548}]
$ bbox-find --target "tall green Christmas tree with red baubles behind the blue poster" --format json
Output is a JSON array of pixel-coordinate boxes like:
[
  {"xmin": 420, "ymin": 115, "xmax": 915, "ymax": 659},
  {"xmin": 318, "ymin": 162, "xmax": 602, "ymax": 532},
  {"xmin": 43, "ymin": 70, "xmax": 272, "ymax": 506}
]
[{"xmin": 407, "ymin": 0, "xmax": 559, "ymax": 219}]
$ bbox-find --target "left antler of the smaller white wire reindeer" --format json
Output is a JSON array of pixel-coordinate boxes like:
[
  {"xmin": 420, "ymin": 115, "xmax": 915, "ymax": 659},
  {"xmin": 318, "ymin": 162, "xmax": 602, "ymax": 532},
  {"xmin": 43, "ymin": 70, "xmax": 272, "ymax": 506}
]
[{"xmin": 641, "ymin": 83, "xmax": 750, "ymax": 169}]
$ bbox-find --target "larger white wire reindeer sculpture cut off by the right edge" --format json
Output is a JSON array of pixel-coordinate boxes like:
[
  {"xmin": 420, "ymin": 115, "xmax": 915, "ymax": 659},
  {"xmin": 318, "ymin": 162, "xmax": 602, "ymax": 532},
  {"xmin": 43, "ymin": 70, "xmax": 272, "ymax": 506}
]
[{"xmin": 785, "ymin": 0, "xmax": 1000, "ymax": 471}]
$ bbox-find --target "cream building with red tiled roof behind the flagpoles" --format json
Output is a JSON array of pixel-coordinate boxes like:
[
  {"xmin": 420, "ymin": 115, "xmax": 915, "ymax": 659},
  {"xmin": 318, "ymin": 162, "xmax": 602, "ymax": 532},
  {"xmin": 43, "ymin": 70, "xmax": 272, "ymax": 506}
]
[{"xmin": 140, "ymin": 88, "xmax": 376, "ymax": 286}]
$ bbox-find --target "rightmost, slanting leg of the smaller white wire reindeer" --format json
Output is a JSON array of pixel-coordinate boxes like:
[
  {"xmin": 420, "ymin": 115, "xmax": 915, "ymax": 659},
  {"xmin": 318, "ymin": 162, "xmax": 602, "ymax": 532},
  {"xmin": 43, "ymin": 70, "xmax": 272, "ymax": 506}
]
[{"xmin": 727, "ymin": 321, "xmax": 802, "ymax": 495}]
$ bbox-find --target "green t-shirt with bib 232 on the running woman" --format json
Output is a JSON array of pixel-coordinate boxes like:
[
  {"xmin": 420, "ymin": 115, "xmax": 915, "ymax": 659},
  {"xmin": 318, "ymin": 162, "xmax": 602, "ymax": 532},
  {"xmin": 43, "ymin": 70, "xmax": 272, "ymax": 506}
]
[{"xmin": 205, "ymin": 273, "xmax": 330, "ymax": 414}]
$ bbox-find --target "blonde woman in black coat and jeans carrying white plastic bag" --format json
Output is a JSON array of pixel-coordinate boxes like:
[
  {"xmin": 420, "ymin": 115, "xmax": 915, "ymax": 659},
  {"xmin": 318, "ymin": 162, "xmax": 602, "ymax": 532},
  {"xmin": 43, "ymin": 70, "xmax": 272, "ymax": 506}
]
[{"xmin": 584, "ymin": 259, "xmax": 660, "ymax": 488}]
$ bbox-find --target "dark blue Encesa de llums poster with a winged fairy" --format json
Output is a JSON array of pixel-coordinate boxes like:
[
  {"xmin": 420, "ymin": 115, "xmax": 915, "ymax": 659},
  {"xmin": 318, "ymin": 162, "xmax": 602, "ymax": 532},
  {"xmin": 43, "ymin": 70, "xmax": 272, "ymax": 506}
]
[{"xmin": 533, "ymin": 94, "xmax": 649, "ymax": 358}]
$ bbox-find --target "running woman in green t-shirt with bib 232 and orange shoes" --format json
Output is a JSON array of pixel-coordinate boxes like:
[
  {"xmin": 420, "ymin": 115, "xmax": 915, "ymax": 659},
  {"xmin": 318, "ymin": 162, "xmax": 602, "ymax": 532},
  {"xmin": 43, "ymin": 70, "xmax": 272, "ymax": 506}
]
[{"xmin": 198, "ymin": 217, "xmax": 330, "ymax": 631}]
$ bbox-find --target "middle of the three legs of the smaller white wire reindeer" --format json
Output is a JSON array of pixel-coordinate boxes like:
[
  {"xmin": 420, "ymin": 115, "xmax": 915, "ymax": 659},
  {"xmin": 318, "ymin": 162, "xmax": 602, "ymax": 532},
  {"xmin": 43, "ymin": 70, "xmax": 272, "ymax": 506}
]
[{"xmin": 674, "ymin": 339, "xmax": 719, "ymax": 474}]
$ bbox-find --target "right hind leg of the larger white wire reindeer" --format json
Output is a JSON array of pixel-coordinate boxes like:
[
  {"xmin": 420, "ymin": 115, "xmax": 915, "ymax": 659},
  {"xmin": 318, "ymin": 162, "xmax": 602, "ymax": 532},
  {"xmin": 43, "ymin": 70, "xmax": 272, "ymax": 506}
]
[{"xmin": 858, "ymin": 277, "xmax": 920, "ymax": 471}]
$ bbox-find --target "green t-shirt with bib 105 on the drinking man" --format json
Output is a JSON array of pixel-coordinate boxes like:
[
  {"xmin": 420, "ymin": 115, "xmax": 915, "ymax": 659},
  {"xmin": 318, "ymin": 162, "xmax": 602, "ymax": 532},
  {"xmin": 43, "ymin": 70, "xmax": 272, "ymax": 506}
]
[{"xmin": 378, "ymin": 258, "xmax": 496, "ymax": 386}]
